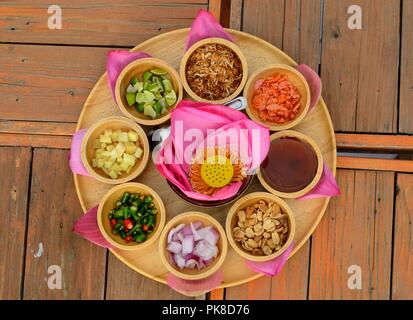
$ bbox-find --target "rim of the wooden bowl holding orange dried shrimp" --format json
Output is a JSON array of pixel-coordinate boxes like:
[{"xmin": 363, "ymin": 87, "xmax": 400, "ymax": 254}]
[{"xmin": 243, "ymin": 63, "xmax": 311, "ymax": 131}]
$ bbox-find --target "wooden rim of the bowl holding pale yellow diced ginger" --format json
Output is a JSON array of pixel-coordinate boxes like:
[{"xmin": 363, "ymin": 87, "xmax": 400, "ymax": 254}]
[{"xmin": 80, "ymin": 116, "xmax": 150, "ymax": 184}]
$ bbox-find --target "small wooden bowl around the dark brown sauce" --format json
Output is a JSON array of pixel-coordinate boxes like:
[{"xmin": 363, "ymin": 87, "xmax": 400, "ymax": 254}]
[{"xmin": 257, "ymin": 130, "xmax": 323, "ymax": 199}]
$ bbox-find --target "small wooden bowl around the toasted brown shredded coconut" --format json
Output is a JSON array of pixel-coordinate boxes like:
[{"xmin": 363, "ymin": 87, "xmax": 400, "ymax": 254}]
[{"xmin": 179, "ymin": 38, "xmax": 248, "ymax": 104}]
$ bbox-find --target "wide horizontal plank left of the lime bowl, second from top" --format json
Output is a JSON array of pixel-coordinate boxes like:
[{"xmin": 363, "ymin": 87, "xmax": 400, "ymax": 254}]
[{"xmin": 0, "ymin": 44, "xmax": 110, "ymax": 122}]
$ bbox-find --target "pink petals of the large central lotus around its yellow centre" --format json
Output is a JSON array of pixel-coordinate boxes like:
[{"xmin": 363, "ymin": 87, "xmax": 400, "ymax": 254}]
[{"xmin": 156, "ymin": 100, "xmax": 270, "ymax": 200}]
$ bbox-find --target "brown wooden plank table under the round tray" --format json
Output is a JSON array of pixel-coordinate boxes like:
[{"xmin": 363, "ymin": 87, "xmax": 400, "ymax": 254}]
[{"xmin": 0, "ymin": 0, "xmax": 413, "ymax": 299}]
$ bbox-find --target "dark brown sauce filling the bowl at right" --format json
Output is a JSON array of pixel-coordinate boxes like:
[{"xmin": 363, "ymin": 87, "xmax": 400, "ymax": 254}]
[{"xmin": 261, "ymin": 137, "xmax": 318, "ymax": 193}]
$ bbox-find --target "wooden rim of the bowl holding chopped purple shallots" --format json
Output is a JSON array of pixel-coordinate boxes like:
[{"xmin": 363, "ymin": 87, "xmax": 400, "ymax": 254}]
[{"xmin": 158, "ymin": 211, "xmax": 228, "ymax": 280}]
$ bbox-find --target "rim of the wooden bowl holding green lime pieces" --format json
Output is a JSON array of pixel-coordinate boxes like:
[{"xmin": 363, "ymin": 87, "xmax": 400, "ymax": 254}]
[{"xmin": 115, "ymin": 57, "xmax": 183, "ymax": 126}]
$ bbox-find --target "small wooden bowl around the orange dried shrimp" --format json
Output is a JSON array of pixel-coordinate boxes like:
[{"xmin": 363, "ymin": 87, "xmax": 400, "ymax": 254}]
[{"xmin": 244, "ymin": 64, "xmax": 311, "ymax": 131}]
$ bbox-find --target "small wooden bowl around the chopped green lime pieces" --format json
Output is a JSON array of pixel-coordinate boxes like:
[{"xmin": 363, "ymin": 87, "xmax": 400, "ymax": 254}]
[{"xmin": 115, "ymin": 58, "xmax": 183, "ymax": 126}]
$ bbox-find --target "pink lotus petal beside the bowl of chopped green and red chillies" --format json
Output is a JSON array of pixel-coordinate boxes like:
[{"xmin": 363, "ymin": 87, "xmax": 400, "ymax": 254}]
[{"xmin": 73, "ymin": 206, "xmax": 113, "ymax": 249}]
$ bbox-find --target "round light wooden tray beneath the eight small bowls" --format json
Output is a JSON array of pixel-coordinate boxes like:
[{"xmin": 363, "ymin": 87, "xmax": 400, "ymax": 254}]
[{"xmin": 74, "ymin": 29, "xmax": 336, "ymax": 288}]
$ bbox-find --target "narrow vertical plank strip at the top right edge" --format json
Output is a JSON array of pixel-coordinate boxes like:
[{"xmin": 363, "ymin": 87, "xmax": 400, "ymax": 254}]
[{"xmin": 399, "ymin": 1, "xmax": 413, "ymax": 133}]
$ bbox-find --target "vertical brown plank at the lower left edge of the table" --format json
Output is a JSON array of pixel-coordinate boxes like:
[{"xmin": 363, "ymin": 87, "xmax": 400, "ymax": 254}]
[{"xmin": 0, "ymin": 147, "xmax": 32, "ymax": 300}]
